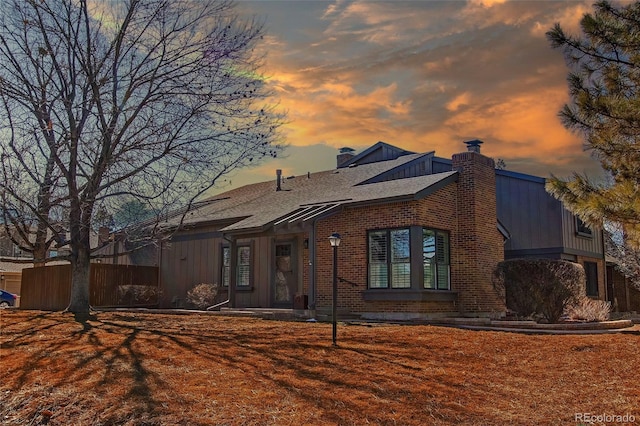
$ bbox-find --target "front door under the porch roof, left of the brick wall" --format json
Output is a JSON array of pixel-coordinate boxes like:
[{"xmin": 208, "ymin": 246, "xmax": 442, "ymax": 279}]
[{"xmin": 272, "ymin": 242, "xmax": 298, "ymax": 308}]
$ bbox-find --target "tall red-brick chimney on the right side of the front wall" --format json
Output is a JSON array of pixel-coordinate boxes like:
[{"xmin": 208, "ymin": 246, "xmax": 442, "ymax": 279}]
[{"xmin": 452, "ymin": 140, "xmax": 505, "ymax": 315}]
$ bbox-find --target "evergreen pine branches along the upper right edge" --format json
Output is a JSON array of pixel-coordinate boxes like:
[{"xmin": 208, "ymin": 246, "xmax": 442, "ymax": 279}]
[{"xmin": 547, "ymin": 1, "xmax": 640, "ymax": 288}]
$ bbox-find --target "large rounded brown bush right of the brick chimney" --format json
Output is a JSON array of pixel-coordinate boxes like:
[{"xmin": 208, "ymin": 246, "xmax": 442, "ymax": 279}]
[{"xmin": 493, "ymin": 259, "xmax": 586, "ymax": 323}]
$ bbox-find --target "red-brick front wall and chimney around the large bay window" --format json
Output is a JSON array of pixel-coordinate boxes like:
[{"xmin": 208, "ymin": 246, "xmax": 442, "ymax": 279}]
[{"xmin": 315, "ymin": 153, "xmax": 504, "ymax": 314}]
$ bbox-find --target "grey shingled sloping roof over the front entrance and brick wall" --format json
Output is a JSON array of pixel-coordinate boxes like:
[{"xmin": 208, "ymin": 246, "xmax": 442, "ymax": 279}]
[{"xmin": 167, "ymin": 154, "xmax": 457, "ymax": 233}]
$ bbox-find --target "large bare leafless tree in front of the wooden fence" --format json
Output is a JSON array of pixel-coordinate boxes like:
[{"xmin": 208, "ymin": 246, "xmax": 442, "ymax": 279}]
[{"xmin": 0, "ymin": 0, "xmax": 283, "ymax": 313}]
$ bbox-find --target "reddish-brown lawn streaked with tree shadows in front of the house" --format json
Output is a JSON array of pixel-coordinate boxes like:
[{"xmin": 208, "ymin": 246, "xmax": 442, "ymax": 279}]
[{"xmin": 0, "ymin": 310, "xmax": 640, "ymax": 425}]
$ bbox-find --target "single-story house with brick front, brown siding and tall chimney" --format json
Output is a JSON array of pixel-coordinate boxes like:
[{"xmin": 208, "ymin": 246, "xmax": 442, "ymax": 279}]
[{"xmin": 152, "ymin": 141, "xmax": 606, "ymax": 319}]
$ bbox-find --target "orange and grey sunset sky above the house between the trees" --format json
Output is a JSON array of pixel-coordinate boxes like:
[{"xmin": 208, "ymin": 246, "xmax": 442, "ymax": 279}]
[{"xmin": 224, "ymin": 0, "xmax": 598, "ymax": 189}]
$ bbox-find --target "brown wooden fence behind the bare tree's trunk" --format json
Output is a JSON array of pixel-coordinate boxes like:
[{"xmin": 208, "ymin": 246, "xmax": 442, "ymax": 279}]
[{"xmin": 20, "ymin": 263, "xmax": 159, "ymax": 311}]
